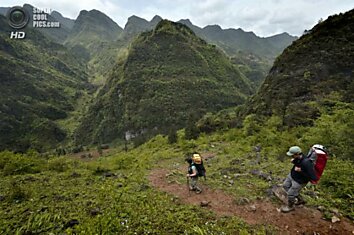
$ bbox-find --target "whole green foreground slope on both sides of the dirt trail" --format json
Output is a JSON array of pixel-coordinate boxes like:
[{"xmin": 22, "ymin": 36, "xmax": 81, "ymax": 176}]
[{"xmin": 0, "ymin": 104, "xmax": 354, "ymax": 234}]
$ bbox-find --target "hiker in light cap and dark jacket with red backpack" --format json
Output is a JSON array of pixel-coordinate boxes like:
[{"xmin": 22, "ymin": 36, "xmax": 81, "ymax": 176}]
[{"xmin": 281, "ymin": 144, "xmax": 327, "ymax": 213}]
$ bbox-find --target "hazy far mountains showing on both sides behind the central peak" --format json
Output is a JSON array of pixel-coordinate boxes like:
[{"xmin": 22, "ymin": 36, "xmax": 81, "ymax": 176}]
[{"xmin": 1, "ymin": 4, "xmax": 296, "ymax": 87}]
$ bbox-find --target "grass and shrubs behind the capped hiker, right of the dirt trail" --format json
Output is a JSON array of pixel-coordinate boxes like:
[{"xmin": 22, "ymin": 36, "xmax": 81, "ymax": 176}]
[{"xmin": 170, "ymin": 106, "xmax": 354, "ymax": 218}]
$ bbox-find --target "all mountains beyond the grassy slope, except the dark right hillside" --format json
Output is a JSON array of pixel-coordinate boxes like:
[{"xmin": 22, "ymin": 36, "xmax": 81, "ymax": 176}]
[{"xmin": 0, "ymin": 4, "xmax": 302, "ymax": 151}]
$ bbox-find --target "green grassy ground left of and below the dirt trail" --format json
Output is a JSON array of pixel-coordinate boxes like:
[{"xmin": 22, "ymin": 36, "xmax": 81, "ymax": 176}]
[{"xmin": 0, "ymin": 143, "xmax": 272, "ymax": 234}]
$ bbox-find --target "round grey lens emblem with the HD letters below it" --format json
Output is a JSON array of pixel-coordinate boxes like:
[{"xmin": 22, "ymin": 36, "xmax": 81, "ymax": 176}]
[{"xmin": 6, "ymin": 6, "xmax": 29, "ymax": 39}]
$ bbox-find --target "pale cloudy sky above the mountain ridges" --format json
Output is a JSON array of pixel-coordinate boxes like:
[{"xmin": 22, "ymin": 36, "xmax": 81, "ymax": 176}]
[{"xmin": 0, "ymin": 0, "xmax": 354, "ymax": 37}]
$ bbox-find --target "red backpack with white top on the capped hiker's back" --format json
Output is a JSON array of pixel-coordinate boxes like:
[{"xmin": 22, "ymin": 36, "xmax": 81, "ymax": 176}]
[{"xmin": 307, "ymin": 144, "xmax": 328, "ymax": 184}]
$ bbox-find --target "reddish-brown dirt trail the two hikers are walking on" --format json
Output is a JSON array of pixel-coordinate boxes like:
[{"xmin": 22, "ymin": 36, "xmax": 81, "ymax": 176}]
[{"xmin": 148, "ymin": 169, "xmax": 354, "ymax": 235}]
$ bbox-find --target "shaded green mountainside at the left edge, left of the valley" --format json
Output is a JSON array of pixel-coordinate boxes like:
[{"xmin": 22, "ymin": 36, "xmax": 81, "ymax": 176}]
[{"xmin": 0, "ymin": 18, "xmax": 89, "ymax": 151}]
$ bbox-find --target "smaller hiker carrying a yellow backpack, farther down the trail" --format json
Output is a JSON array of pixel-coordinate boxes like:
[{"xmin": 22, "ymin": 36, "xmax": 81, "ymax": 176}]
[{"xmin": 186, "ymin": 153, "xmax": 206, "ymax": 194}]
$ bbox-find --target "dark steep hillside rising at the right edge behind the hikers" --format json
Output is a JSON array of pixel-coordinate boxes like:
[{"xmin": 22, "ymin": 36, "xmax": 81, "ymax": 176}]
[{"xmin": 246, "ymin": 10, "xmax": 354, "ymax": 127}]
